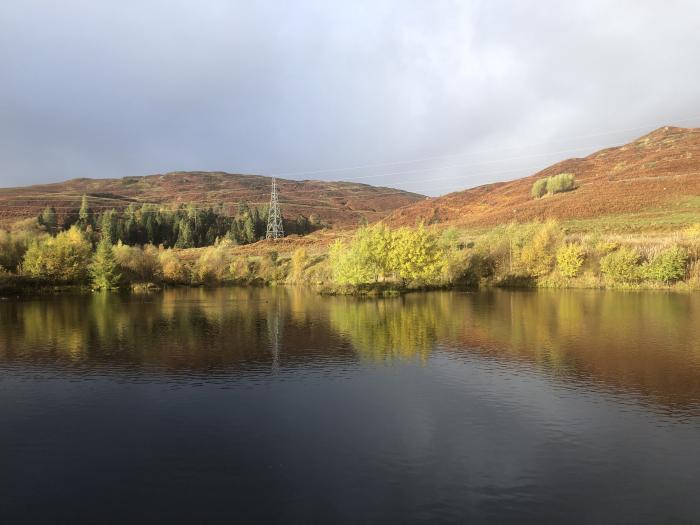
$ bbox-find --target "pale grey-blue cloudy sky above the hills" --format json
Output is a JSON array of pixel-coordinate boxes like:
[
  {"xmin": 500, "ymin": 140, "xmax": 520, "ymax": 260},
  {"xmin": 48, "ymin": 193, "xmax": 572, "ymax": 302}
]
[{"xmin": 0, "ymin": 0, "xmax": 700, "ymax": 195}]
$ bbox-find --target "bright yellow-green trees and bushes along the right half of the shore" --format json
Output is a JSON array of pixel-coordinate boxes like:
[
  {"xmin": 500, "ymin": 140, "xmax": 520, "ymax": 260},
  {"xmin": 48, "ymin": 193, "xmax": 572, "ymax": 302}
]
[{"xmin": 322, "ymin": 221, "xmax": 700, "ymax": 291}]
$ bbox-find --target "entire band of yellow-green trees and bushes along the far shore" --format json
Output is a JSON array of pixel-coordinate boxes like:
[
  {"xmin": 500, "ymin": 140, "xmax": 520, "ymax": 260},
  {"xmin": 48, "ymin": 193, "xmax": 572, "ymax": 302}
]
[{"xmin": 0, "ymin": 204, "xmax": 700, "ymax": 293}]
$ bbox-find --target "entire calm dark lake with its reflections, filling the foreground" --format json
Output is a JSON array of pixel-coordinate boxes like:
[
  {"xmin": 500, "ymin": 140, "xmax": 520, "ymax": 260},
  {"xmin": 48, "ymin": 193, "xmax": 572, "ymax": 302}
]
[{"xmin": 0, "ymin": 289, "xmax": 700, "ymax": 524}]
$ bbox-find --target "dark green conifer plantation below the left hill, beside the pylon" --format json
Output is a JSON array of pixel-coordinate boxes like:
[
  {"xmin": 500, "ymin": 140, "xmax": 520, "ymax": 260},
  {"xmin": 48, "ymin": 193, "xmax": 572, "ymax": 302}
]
[{"xmin": 38, "ymin": 197, "xmax": 322, "ymax": 248}]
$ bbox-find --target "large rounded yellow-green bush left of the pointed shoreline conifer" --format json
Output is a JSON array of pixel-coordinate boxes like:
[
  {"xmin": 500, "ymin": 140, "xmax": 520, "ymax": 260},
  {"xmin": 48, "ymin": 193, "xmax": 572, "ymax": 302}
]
[{"xmin": 22, "ymin": 227, "xmax": 92, "ymax": 284}]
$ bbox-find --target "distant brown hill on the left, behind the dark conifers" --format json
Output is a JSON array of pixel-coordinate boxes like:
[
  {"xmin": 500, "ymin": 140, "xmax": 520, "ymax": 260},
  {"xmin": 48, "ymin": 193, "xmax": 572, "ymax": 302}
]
[{"xmin": 0, "ymin": 172, "xmax": 425, "ymax": 227}]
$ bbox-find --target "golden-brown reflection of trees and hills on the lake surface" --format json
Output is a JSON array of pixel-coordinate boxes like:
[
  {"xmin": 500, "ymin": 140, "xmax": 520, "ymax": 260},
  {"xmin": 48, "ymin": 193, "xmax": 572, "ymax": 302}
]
[{"xmin": 0, "ymin": 288, "xmax": 700, "ymax": 406}]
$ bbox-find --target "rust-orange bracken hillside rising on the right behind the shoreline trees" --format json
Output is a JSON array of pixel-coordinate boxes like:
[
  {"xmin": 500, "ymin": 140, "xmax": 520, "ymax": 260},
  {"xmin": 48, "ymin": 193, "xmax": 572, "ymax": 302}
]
[{"xmin": 387, "ymin": 127, "xmax": 700, "ymax": 230}]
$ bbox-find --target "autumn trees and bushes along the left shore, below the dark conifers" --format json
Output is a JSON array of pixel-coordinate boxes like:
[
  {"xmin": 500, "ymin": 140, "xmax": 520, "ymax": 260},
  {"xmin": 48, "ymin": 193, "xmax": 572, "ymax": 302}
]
[{"xmin": 0, "ymin": 225, "xmax": 306, "ymax": 290}]
